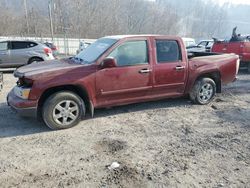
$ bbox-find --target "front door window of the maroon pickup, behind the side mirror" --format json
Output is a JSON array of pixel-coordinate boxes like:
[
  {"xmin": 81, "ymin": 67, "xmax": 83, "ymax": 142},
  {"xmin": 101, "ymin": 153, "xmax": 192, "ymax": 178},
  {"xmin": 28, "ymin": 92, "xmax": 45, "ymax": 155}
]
[{"xmin": 108, "ymin": 41, "xmax": 148, "ymax": 67}]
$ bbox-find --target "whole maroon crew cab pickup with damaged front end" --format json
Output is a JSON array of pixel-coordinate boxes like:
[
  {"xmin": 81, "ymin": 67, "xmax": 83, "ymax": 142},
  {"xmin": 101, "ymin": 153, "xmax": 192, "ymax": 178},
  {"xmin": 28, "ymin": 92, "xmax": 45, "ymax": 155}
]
[{"xmin": 7, "ymin": 35, "xmax": 239, "ymax": 129}]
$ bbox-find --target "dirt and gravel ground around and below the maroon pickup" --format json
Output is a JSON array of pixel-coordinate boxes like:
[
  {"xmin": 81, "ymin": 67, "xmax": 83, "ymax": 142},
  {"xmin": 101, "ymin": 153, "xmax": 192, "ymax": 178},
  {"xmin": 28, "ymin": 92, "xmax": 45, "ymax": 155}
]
[{"xmin": 0, "ymin": 71, "xmax": 250, "ymax": 187}]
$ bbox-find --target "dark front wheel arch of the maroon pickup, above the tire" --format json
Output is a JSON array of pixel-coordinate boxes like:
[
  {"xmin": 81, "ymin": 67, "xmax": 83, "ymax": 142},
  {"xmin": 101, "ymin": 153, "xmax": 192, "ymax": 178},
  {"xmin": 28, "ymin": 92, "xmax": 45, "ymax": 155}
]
[{"xmin": 37, "ymin": 85, "xmax": 94, "ymax": 119}]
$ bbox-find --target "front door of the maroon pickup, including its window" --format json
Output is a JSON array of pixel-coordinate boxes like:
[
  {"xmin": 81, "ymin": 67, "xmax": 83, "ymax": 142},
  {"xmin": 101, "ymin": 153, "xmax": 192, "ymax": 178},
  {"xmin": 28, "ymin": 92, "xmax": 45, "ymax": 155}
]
[{"xmin": 96, "ymin": 40, "xmax": 152, "ymax": 106}]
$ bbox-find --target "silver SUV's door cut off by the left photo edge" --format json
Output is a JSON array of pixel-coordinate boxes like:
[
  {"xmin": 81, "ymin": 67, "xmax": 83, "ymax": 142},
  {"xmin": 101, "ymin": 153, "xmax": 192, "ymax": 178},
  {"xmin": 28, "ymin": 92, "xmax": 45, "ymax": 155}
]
[{"xmin": 0, "ymin": 41, "xmax": 10, "ymax": 67}]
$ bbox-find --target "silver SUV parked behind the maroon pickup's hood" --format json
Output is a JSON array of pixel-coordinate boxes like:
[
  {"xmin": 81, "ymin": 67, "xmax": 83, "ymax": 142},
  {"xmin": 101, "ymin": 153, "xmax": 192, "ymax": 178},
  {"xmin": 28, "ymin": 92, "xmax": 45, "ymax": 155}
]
[{"xmin": 0, "ymin": 40, "xmax": 54, "ymax": 68}]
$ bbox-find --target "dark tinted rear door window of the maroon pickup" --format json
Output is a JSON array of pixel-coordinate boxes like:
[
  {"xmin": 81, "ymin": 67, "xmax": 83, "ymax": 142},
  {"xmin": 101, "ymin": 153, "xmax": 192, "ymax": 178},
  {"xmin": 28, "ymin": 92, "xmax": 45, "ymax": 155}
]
[{"xmin": 156, "ymin": 40, "xmax": 181, "ymax": 63}]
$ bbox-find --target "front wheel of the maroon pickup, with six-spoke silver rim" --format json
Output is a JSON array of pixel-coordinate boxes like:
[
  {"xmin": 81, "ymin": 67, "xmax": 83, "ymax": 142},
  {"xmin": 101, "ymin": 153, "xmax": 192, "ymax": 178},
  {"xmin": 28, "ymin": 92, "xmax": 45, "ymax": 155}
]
[{"xmin": 42, "ymin": 91, "xmax": 86, "ymax": 130}]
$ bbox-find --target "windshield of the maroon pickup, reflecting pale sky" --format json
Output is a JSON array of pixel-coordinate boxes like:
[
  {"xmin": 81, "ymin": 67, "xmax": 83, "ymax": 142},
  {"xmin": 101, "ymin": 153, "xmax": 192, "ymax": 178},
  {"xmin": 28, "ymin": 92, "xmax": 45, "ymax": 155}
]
[{"xmin": 74, "ymin": 38, "xmax": 117, "ymax": 63}]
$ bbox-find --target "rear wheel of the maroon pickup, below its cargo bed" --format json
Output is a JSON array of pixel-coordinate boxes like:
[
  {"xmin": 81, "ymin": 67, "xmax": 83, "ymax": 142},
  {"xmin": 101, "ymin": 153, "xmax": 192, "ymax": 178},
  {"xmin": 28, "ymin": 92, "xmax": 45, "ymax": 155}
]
[{"xmin": 189, "ymin": 78, "xmax": 216, "ymax": 105}]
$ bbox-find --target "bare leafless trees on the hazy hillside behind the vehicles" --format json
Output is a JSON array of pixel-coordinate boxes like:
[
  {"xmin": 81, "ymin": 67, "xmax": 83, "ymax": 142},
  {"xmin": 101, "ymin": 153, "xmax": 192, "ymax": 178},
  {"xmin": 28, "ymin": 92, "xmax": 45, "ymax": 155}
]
[{"xmin": 0, "ymin": 0, "xmax": 227, "ymax": 38}]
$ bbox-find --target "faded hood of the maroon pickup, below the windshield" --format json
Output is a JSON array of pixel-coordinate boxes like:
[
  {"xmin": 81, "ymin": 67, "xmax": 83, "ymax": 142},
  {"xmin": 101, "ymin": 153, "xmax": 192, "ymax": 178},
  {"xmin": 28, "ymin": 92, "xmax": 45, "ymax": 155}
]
[{"xmin": 14, "ymin": 59, "xmax": 86, "ymax": 78}]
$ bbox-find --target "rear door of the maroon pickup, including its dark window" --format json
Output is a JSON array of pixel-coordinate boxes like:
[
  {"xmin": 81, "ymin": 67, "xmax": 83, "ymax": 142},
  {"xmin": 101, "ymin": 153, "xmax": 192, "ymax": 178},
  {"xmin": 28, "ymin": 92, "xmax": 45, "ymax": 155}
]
[{"xmin": 153, "ymin": 38, "xmax": 188, "ymax": 96}]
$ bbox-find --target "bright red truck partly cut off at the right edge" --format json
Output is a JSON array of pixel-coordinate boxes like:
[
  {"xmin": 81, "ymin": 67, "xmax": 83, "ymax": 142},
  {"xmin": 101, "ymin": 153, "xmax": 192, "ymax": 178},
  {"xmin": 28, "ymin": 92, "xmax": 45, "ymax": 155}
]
[{"xmin": 212, "ymin": 36, "xmax": 250, "ymax": 73}]
